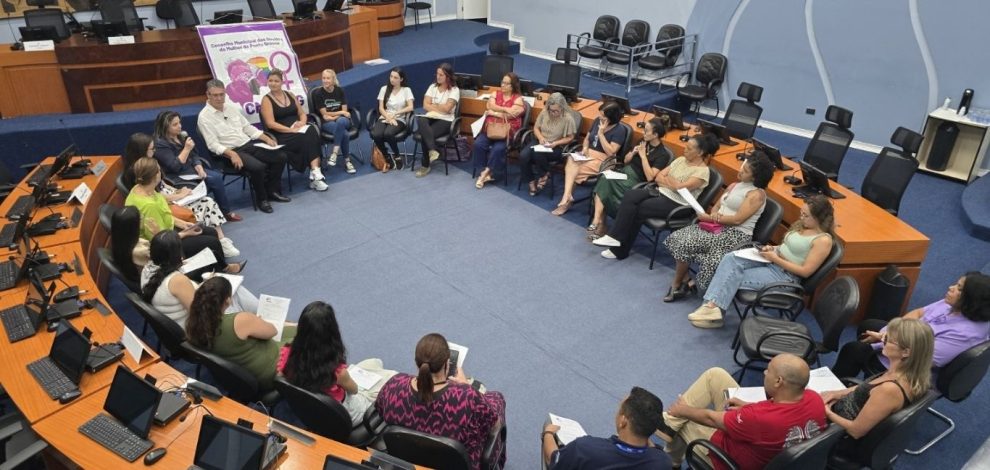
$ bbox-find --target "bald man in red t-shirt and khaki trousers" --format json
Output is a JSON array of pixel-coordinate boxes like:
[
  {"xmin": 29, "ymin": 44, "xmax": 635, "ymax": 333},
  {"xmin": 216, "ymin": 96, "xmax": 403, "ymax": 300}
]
[{"xmin": 657, "ymin": 354, "xmax": 828, "ymax": 470}]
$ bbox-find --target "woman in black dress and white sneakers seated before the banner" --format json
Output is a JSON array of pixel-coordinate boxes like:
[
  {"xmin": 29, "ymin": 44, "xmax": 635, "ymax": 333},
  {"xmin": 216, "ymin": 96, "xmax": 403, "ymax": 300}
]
[{"xmin": 258, "ymin": 69, "xmax": 328, "ymax": 191}]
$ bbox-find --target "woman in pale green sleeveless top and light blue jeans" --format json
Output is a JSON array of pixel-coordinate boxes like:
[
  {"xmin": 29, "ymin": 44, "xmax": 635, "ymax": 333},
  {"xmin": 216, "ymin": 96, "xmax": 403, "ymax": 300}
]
[{"xmin": 688, "ymin": 195, "xmax": 835, "ymax": 328}]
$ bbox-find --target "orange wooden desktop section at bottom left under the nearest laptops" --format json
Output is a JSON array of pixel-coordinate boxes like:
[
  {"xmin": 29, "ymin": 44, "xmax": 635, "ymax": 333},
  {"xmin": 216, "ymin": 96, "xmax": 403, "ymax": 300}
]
[{"xmin": 34, "ymin": 362, "xmax": 380, "ymax": 469}]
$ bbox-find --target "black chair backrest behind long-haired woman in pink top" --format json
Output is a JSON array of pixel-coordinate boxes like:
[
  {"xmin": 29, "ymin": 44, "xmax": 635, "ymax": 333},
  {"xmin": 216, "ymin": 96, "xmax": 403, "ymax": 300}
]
[{"xmin": 275, "ymin": 376, "xmax": 351, "ymax": 444}]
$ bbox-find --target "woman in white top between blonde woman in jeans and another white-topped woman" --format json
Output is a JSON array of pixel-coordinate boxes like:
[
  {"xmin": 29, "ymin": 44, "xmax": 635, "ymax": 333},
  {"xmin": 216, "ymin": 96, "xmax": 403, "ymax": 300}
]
[{"xmin": 371, "ymin": 67, "xmax": 413, "ymax": 171}]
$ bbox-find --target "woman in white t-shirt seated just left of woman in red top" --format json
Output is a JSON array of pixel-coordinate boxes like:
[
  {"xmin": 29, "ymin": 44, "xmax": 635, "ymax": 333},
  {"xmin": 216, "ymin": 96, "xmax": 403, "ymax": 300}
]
[{"xmin": 416, "ymin": 62, "xmax": 461, "ymax": 178}]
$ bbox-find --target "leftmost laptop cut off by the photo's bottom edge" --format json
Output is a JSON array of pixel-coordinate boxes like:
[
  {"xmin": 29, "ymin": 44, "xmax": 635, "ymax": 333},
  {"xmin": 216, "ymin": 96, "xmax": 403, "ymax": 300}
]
[{"xmin": 189, "ymin": 415, "xmax": 286, "ymax": 470}]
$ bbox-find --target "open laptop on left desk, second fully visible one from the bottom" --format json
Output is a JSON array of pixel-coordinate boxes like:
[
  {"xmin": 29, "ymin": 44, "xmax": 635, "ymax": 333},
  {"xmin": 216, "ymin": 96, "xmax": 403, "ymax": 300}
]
[{"xmin": 27, "ymin": 322, "xmax": 90, "ymax": 400}]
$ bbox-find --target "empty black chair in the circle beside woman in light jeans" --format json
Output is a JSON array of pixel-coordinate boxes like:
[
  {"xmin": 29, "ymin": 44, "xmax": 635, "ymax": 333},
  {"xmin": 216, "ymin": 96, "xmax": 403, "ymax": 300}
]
[{"xmin": 732, "ymin": 276, "xmax": 859, "ymax": 383}]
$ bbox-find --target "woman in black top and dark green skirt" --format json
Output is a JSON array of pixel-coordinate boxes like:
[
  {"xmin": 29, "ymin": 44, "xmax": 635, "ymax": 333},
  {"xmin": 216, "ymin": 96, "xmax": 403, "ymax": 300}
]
[{"xmin": 588, "ymin": 118, "xmax": 673, "ymax": 240}]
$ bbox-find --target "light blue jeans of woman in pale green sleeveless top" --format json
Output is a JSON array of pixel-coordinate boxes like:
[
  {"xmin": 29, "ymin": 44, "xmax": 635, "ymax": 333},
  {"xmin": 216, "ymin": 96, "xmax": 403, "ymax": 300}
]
[{"xmin": 705, "ymin": 252, "xmax": 800, "ymax": 310}]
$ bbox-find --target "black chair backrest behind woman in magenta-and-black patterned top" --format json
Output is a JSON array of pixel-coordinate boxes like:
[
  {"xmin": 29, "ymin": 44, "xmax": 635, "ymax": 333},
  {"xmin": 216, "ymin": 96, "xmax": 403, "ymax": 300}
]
[{"xmin": 382, "ymin": 425, "xmax": 471, "ymax": 470}]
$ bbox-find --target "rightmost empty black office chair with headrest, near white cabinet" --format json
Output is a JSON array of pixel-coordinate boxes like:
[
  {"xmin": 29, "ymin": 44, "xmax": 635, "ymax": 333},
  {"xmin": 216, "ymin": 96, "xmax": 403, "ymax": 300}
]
[{"xmin": 860, "ymin": 127, "xmax": 924, "ymax": 215}]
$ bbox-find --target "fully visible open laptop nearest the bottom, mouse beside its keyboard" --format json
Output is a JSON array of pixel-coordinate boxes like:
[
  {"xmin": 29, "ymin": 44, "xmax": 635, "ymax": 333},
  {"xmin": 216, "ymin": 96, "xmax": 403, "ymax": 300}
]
[{"xmin": 79, "ymin": 366, "xmax": 162, "ymax": 462}]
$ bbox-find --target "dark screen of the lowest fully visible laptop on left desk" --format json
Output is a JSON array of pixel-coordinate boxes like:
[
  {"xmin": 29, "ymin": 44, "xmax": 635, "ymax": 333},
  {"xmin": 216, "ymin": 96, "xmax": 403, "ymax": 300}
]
[{"xmin": 103, "ymin": 366, "xmax": 162, "ymax": 439}]
